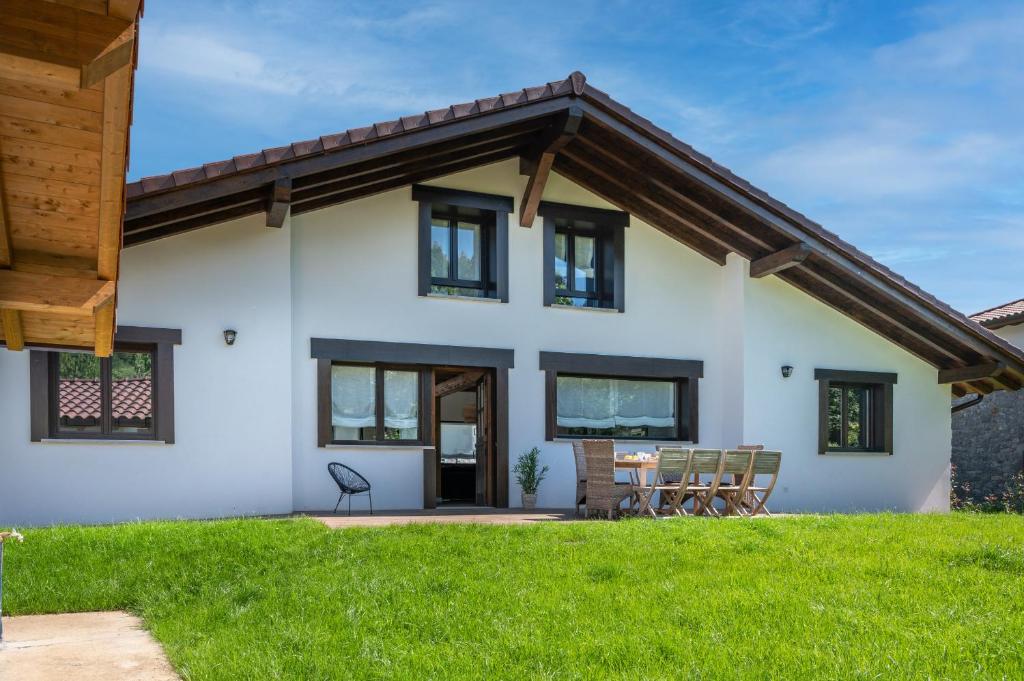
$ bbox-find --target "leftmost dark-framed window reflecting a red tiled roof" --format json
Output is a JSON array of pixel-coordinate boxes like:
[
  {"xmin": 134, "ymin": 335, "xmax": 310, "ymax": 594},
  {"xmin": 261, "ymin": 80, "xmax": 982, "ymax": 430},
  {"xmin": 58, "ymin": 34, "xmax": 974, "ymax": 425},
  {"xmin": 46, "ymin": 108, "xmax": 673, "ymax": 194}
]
[{"xmin": 31, "ymin": 327, "xmax": 181, "ymax": 442}]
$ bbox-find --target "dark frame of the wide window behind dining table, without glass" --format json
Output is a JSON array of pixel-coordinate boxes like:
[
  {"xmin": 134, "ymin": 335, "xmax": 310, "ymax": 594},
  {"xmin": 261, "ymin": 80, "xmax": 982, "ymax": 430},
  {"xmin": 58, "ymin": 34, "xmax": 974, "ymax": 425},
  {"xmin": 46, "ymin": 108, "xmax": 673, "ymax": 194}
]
[{"xmin": 540, "ymin": 350, "xmax": 703, "ymax": 442}]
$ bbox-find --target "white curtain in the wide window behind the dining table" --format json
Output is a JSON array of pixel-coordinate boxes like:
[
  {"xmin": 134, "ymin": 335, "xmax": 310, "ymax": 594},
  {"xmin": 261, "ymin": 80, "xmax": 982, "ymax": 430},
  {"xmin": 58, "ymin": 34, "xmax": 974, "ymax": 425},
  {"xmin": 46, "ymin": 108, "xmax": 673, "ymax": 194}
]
[{"xmin": 557, "ymin": 376, "xmax": 676, "ymax": 428}]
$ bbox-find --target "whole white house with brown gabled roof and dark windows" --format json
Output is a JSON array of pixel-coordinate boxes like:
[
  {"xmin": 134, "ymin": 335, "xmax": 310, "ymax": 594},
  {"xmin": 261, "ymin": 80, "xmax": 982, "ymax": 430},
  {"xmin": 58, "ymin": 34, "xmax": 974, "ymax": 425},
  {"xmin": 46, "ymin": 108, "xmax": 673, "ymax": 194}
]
[{"xmin": 0, "ymin": 73, "xmax": 1024, "ymax": 524}]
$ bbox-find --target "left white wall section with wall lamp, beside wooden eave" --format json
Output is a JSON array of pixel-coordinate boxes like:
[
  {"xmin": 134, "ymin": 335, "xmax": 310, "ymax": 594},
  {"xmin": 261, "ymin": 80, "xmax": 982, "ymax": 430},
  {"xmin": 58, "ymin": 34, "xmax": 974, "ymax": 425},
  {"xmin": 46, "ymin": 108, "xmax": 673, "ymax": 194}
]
[{"xmin": 0, "ymin": 216, "xmax": 292, "ymax": 525}]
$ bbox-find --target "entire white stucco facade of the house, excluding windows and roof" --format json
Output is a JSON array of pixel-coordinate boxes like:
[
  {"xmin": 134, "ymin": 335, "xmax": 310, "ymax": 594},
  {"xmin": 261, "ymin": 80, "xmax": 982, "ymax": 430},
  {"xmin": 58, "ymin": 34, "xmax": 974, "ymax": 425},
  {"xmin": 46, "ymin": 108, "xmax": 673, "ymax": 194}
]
[{"xmin": 0, "ymin": 160, "xmax": 950, "ymax": 524}]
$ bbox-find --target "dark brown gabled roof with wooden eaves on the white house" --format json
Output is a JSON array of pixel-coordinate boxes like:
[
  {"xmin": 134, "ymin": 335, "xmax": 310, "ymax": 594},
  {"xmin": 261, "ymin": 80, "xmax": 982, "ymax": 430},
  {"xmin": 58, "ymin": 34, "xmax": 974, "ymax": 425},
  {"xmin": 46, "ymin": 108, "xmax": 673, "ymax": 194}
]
[{"xmin": 125, "ymin": 72, "xmax": 1024, "ymax": 394}]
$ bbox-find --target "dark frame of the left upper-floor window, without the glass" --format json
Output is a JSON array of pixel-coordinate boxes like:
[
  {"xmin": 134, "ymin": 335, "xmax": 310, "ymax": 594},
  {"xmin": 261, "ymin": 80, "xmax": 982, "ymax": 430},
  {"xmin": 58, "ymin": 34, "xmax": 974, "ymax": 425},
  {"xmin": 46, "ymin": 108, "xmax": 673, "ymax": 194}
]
[{"xmin": 412, "ymin": 184, "xmax": 513, "ymax": 303}]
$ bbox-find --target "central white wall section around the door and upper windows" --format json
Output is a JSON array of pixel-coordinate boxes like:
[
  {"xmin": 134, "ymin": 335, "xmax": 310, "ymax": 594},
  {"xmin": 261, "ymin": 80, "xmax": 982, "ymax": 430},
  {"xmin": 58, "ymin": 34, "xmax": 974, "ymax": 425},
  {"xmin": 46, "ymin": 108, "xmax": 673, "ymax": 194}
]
[{"xmin": 293, "ymin": 160, "xmax": 724, "ymax": 510}]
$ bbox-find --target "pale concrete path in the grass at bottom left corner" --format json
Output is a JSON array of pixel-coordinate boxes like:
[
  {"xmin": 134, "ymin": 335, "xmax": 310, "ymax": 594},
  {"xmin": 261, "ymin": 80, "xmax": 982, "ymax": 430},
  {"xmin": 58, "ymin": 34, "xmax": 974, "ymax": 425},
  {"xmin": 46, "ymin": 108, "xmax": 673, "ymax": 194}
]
[{"xmin": 0, "ymin": 612, "xmax": 178, "ymax": 681}]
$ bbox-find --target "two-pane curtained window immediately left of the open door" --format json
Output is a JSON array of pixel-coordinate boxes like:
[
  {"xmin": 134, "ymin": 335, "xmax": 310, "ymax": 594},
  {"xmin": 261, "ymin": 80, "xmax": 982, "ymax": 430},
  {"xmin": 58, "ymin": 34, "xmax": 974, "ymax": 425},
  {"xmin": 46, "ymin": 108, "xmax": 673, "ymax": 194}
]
[{"xmin": 331, "ymin": 364, "xmax": 421, "ymax": 444}]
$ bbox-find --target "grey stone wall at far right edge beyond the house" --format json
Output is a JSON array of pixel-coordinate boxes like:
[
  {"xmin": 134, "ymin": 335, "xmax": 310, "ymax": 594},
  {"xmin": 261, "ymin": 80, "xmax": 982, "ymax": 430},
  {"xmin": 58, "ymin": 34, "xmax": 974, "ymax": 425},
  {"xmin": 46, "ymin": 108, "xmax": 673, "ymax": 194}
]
[{"xmin": 952, "ymin": 390, "xmax": 1024, "ymax": 501}]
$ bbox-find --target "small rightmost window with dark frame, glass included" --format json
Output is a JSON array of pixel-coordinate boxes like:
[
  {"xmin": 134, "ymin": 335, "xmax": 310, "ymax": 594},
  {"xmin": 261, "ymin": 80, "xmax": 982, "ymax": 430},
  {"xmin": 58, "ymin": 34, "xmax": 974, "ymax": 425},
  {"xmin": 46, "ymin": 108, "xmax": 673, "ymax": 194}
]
[{"xmin": 814, "ymin": 369, "xmax": 896, "ymax": 454}]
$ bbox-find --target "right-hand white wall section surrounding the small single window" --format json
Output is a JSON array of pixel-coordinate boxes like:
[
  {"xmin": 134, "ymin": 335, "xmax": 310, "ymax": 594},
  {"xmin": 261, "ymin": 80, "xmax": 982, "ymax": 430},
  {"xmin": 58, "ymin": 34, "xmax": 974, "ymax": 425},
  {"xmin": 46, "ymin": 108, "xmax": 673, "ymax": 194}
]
[{"xmin": 743, "ymin": 263, "xmax": 951, "ymax": 511}]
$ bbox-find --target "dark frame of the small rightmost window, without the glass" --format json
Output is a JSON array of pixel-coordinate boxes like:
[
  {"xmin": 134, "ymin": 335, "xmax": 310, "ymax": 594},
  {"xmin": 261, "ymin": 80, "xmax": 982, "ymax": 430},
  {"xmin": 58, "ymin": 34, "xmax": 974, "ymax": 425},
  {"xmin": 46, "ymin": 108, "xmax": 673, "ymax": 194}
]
[{"xmin": 814, "ymin": 369, "xmax": 898, "ymax": 456}]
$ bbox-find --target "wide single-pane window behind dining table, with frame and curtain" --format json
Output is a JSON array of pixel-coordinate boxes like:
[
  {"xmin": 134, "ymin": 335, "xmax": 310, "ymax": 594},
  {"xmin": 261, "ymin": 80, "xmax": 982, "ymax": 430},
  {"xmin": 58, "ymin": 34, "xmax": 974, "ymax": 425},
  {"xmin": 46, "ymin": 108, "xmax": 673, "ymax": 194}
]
[{"xmin": 541, "ymin": 352, "xmax": 703, "ymax": 441}]
